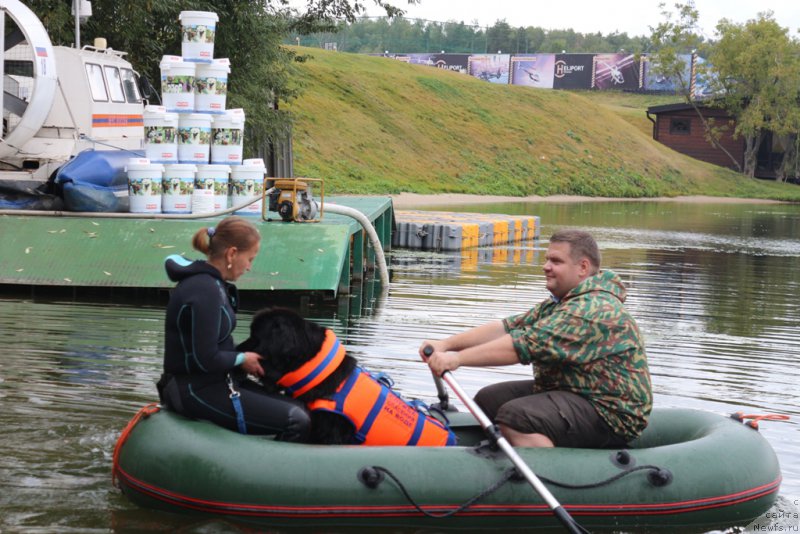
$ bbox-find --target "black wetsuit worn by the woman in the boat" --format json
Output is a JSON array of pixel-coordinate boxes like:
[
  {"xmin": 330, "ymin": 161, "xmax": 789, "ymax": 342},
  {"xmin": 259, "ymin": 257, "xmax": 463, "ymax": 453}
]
[{"xmin": 159, "ymin": 255, "xmax": 310, "ymax": 441}]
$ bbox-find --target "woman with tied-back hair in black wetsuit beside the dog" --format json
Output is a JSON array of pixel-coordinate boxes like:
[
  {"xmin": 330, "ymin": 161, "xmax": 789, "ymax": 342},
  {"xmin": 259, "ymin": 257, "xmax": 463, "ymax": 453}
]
[{"xmin": 159, "ymin": 217, "xmax": 310, "ymax": 441}]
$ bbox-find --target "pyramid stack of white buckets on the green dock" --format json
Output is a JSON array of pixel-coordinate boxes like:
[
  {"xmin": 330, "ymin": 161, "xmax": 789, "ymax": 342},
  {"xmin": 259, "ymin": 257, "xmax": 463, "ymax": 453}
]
[{"xmin": 128, "ymin": 11, "xmax": 266, "ymax": 215}]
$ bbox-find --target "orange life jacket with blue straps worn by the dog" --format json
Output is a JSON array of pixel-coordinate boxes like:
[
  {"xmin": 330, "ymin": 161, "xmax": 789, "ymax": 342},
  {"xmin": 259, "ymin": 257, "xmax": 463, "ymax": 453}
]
[{"xmin": 278, "ymin": 330, "xmax": 456, "ymax": 447}]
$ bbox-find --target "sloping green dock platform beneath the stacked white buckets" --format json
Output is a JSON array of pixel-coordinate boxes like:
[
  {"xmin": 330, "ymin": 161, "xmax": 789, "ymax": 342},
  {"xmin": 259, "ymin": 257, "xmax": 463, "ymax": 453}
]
[{"xmin": 0, "ymin": 197, "xmax": 394, "ymax": 297}]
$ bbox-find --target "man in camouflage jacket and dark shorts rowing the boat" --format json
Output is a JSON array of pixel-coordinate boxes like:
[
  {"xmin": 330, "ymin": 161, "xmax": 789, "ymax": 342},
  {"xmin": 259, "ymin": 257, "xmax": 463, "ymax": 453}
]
[{"xmin": 420, "ymin": 230, "xmax": 652, "ymax": 448}]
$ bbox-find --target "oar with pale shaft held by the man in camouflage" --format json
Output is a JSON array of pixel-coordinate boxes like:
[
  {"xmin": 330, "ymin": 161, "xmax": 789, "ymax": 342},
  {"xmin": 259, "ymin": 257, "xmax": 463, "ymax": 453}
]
[{"xmin": 422, "ymin": 346, "xmax": 589, "ymax": 534}]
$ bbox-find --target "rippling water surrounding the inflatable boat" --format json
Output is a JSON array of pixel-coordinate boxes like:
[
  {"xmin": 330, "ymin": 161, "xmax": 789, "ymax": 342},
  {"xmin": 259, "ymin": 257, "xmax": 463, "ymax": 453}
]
[{"xmin": 0, "ymin": 202, "xmax": 800, "ymax": 532}]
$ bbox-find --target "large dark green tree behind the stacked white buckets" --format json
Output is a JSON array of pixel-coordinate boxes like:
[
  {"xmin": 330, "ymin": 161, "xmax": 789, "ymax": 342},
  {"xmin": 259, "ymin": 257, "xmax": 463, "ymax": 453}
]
[{"xmin": 26, "ymin": 0, "xmax": 418, "ymax": 159}]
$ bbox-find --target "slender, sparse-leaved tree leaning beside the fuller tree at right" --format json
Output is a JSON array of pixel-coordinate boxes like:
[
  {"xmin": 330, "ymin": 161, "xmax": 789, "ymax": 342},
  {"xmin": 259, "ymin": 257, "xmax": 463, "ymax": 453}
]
[{"xmin": 649, "ymin": 0, "xmax": 742, "ymax": 172}]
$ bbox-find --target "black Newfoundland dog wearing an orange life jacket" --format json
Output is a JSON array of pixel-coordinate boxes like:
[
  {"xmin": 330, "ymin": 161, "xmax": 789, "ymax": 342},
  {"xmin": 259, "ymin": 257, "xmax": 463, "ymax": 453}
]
[{"xmin": 237, "ymin": 308, "xmax": 455, "ymax": 446}]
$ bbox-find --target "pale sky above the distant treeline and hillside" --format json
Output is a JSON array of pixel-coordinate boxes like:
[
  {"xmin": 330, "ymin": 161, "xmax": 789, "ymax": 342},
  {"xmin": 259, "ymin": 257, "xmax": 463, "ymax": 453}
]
[{"xmin": 365, "ymin": 0, "xmax": 800, "ymax": 39}]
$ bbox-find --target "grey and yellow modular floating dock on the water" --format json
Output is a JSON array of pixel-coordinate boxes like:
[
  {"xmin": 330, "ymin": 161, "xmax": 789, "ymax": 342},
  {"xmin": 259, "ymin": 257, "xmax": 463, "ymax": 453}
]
[{"xmin": 392, "ymin": 210, "xmax": 540, "ymax": 251}]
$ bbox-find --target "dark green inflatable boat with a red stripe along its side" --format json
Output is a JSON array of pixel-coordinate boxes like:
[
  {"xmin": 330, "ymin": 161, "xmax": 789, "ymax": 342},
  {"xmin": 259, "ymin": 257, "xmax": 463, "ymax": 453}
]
[{"xmin": 113, "ymin": 405, "xmax": 781, "ymax": 532}]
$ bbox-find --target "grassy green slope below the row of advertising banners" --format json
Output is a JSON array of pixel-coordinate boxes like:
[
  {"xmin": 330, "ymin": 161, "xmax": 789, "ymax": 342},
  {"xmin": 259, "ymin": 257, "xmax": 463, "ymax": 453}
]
[{"xmin": 287, "ymin": 49, "xmax": 800, "ymax": 201}]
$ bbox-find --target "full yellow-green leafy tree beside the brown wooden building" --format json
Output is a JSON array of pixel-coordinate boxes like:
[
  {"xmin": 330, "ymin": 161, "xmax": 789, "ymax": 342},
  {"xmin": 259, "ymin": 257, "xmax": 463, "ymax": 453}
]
[{"xmin": 708, "ymin": 12, "xmax": 800, "ymax": 177}]
